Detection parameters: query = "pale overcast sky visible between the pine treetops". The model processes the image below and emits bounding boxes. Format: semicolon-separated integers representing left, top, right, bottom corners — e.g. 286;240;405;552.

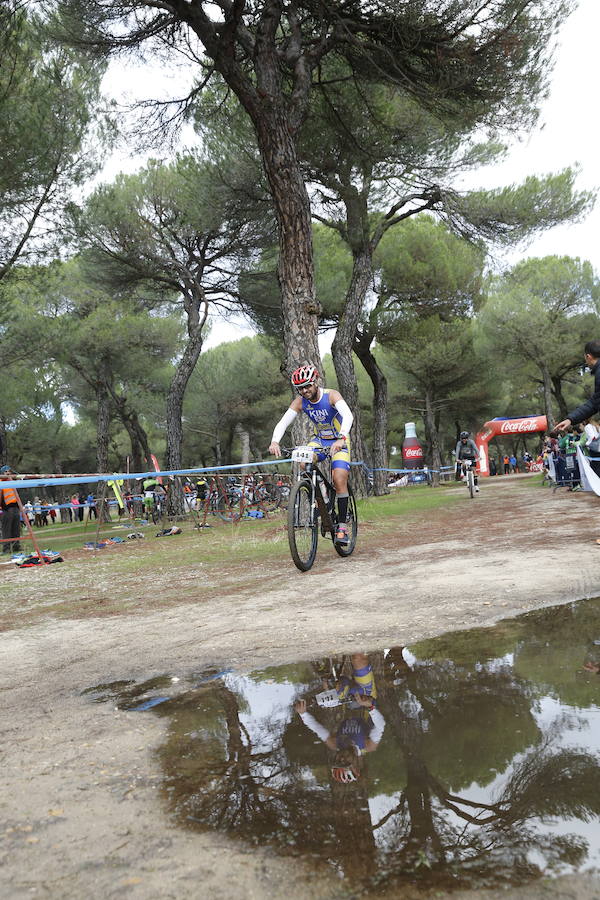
102;0;600;352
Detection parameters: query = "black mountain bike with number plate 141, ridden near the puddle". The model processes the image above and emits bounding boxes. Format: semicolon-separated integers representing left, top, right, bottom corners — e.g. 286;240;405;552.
287;447;358;572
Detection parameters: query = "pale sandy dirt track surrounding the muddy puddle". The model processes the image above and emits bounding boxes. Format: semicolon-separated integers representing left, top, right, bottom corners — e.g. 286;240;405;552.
0;476;600;900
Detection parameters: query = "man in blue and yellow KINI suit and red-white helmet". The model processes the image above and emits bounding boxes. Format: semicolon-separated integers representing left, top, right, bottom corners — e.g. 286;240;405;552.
269;365;354;544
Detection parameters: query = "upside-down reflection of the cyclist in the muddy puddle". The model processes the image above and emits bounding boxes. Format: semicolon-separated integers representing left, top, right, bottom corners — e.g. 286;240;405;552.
294;653;385;784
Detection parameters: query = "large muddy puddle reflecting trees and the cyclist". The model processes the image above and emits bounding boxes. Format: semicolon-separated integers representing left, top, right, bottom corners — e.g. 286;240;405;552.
85;600;600;889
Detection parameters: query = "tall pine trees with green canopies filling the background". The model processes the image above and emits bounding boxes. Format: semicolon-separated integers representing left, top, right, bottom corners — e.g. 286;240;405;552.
0;0;600;506
